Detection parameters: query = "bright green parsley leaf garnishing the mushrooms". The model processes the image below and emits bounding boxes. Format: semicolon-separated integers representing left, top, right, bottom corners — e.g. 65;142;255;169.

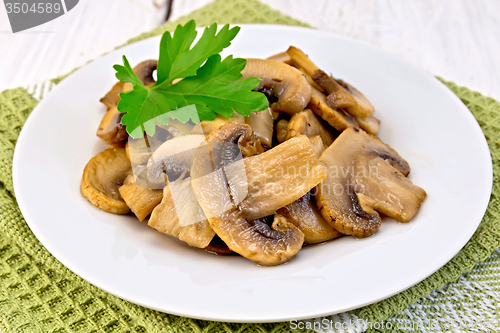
113;21;268;138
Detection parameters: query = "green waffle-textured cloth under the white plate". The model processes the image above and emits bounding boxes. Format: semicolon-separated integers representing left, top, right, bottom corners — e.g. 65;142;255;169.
0;0;500;333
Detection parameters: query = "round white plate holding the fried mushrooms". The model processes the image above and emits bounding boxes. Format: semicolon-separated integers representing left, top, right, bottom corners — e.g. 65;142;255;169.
13;25;492;322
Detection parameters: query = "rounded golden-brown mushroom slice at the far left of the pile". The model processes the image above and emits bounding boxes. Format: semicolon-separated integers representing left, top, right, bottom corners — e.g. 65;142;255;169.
80;148;131;214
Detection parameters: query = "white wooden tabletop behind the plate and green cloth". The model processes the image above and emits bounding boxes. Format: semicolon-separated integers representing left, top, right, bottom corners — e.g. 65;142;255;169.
0;0;500;100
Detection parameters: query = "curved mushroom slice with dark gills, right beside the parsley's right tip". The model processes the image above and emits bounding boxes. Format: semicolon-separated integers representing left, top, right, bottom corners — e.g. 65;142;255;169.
241;59;311;114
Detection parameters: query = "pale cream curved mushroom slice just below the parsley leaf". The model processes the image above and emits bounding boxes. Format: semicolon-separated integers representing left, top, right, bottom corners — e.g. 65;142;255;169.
146;134;205;188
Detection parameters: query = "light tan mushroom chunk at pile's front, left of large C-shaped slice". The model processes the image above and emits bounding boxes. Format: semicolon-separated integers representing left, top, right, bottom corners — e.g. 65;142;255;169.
148;178;215;249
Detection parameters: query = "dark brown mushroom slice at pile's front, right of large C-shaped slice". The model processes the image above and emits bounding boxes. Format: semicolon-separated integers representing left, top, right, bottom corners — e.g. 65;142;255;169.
278;193;342;244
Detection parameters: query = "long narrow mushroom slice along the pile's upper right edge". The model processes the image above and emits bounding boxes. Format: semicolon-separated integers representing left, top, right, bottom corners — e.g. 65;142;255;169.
287;46;375;118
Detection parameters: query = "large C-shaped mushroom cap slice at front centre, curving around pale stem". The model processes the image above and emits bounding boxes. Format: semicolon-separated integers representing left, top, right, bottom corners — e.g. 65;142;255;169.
191;123;307;265
